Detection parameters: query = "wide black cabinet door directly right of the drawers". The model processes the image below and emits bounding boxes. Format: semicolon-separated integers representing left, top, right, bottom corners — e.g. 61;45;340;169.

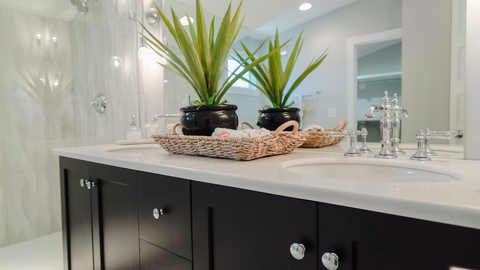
192;182;317;270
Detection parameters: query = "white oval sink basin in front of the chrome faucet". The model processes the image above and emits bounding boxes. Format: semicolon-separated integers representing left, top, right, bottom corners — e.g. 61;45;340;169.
282;159;466;183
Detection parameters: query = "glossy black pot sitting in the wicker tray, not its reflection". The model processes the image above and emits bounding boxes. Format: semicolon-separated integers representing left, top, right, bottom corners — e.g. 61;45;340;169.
180;104;238;136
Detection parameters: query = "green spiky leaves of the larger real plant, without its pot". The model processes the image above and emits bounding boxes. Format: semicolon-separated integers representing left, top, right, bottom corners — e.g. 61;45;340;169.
140;0;286;105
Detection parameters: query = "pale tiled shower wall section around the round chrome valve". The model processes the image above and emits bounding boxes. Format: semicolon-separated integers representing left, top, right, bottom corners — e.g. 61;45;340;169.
71;0;140;145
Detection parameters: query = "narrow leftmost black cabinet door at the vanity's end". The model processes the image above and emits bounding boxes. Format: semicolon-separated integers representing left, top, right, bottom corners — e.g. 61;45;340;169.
60;158;93;270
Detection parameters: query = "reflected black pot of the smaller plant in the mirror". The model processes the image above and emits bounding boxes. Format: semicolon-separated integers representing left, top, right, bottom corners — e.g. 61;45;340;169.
257;108;300;131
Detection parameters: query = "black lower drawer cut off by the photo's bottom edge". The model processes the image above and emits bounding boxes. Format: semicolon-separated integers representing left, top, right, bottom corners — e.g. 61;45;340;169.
140;240;192;270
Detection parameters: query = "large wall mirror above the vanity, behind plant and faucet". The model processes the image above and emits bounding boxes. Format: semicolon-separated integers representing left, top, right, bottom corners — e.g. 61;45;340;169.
165;0;466;152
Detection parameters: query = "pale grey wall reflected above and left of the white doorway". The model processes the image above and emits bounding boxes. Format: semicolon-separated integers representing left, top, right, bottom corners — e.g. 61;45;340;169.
281;0;402;128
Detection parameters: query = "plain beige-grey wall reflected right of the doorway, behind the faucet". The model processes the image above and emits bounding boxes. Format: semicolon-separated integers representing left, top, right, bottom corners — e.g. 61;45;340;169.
402;0;452;143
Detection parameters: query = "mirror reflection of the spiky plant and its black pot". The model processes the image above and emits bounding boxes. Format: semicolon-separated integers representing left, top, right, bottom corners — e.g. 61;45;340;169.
235;29;328;130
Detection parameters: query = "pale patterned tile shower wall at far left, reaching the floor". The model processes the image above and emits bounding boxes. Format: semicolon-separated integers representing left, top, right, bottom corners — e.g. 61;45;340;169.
0;5;77;246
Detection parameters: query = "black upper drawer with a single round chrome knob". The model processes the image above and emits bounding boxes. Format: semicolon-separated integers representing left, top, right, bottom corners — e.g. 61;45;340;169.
138;172;192;260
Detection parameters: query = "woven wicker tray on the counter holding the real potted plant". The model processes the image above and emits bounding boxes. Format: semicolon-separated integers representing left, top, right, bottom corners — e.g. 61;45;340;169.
152;121;309;160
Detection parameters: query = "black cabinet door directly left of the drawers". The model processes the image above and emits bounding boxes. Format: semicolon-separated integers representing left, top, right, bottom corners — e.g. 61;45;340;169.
91;164;140;270
